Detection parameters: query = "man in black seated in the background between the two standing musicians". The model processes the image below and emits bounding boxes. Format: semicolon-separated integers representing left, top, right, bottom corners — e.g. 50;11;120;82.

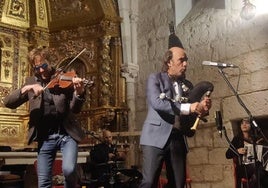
90;130;126;186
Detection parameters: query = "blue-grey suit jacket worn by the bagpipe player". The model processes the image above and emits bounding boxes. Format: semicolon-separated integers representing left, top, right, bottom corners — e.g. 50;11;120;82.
140;72;194;148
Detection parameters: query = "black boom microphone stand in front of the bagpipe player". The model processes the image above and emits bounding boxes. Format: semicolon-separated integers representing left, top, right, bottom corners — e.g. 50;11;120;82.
218;67;267;188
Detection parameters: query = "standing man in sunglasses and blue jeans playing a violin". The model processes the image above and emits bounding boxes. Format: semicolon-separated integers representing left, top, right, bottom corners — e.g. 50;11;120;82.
4;48;85;188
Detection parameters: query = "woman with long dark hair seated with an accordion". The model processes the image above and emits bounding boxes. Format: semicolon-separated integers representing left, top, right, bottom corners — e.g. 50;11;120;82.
225;118;267;188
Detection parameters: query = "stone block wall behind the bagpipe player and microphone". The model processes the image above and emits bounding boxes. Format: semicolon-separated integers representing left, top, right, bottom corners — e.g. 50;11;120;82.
136;0;268;188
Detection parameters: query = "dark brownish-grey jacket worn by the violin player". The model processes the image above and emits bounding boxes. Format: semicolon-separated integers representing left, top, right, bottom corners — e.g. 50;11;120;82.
4;76;85;144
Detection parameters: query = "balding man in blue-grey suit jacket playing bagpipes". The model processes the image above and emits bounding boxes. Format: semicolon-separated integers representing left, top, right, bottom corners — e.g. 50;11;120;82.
140;34;211;188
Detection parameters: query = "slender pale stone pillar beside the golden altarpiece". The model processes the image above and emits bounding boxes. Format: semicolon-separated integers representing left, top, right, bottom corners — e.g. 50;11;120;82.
118;0;139;167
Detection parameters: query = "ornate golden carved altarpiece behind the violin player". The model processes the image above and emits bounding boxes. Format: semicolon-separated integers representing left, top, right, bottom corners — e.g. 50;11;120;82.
0;0;128;148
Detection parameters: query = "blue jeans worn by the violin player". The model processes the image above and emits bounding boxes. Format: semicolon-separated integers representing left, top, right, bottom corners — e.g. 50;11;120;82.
37;134;78;188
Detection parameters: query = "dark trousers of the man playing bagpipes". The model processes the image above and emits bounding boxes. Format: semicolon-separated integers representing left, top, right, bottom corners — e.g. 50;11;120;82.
140;134;187;188
